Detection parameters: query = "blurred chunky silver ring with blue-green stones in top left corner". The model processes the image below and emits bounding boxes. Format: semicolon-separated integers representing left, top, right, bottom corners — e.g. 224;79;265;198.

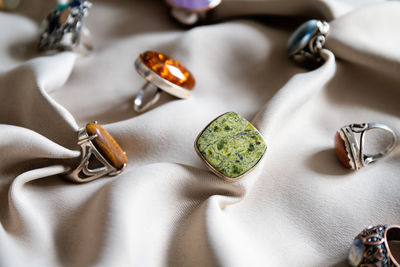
38;0;93;55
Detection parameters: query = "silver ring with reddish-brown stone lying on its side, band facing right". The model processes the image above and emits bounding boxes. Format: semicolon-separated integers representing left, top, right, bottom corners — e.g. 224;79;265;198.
335;122;397;170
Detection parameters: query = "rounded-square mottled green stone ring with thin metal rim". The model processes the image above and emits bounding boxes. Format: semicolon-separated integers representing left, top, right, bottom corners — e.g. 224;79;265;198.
196;112;267;178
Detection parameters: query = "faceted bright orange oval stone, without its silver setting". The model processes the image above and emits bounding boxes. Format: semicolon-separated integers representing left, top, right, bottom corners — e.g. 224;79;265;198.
140;51;195;90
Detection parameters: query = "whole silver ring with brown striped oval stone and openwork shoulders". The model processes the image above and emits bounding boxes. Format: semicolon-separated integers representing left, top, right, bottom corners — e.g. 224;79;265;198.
66;122;128;183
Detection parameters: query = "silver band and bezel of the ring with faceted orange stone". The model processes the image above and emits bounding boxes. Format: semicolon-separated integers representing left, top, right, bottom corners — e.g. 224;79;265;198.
133;57;192;112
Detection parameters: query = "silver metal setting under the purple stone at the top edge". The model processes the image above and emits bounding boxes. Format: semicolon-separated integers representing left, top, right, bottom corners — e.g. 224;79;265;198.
166;0;222;26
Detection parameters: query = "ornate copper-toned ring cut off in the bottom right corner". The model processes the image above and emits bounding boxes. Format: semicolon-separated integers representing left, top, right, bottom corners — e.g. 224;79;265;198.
348;225;400;267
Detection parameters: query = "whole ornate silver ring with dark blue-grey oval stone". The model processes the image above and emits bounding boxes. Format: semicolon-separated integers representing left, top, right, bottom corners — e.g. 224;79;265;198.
287;19;329;62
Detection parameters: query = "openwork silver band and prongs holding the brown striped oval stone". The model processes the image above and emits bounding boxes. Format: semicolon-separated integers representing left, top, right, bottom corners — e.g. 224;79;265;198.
66;122;126;183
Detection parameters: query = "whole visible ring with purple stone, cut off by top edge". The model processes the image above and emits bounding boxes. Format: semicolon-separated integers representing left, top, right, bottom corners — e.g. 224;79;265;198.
165;0;221;26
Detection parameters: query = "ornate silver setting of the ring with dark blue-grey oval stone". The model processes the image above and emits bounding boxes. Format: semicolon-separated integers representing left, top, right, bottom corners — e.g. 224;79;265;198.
288;20;330;62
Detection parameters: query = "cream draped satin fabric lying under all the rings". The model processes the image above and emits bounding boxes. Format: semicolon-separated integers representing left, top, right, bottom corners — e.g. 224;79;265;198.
0;0;400;267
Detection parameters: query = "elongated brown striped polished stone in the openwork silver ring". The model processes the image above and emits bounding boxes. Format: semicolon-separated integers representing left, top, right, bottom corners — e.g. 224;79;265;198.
86;122;128;170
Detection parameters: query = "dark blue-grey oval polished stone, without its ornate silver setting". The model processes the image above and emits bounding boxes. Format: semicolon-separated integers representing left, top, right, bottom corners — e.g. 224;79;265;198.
286;19;318;55
